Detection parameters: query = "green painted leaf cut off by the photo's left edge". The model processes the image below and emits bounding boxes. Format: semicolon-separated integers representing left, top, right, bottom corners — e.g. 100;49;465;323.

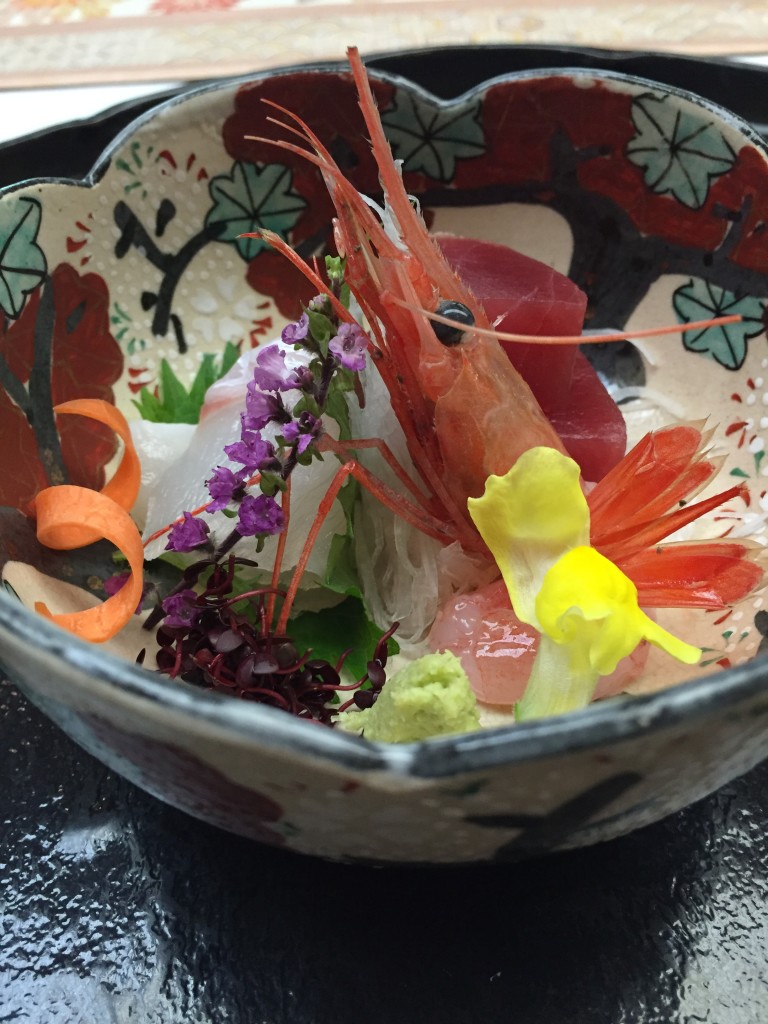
0;196;46;317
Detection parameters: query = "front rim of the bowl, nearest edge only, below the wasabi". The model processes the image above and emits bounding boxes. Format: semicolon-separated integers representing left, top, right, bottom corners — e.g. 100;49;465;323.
0;591;768;778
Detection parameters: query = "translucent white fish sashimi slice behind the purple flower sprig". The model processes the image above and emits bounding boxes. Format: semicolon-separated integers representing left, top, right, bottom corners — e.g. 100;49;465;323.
139;342;346;583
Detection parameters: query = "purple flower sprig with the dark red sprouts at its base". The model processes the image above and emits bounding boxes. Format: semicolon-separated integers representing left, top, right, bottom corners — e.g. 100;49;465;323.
144;259;405;725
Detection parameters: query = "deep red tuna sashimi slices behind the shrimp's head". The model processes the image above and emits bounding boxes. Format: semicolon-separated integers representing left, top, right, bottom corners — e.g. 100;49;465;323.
435;233;627;481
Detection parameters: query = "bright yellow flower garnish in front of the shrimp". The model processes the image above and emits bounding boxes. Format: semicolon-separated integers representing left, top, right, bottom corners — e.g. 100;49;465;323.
468;447;700;720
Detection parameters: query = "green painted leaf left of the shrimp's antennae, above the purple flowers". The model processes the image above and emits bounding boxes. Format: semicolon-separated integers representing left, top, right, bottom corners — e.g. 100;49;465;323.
206;161;306;260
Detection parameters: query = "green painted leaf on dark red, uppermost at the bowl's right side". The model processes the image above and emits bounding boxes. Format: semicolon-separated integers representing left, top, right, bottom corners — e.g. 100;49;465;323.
627;93;736;210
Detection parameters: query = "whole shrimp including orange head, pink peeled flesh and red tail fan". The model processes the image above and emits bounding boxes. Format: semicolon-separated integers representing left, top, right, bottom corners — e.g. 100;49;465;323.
257;49;762;703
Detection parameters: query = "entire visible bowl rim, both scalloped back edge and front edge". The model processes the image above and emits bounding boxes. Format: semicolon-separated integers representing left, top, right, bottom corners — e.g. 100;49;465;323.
0;60;768;778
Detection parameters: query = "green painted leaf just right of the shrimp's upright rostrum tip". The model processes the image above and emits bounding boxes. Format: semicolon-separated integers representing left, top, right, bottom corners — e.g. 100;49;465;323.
381;89;485;182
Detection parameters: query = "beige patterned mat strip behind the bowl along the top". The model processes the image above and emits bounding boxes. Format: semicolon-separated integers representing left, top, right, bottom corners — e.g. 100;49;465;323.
0;0;768;88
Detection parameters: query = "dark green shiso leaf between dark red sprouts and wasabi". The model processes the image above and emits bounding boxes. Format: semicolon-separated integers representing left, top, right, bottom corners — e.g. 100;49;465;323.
288;597;399;679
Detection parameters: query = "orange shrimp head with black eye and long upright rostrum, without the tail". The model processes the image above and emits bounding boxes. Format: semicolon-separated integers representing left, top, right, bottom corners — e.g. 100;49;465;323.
263;49;564;549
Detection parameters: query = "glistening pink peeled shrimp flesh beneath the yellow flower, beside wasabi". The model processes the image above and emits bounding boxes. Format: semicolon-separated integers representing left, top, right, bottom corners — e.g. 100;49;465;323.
427;580;648;706
